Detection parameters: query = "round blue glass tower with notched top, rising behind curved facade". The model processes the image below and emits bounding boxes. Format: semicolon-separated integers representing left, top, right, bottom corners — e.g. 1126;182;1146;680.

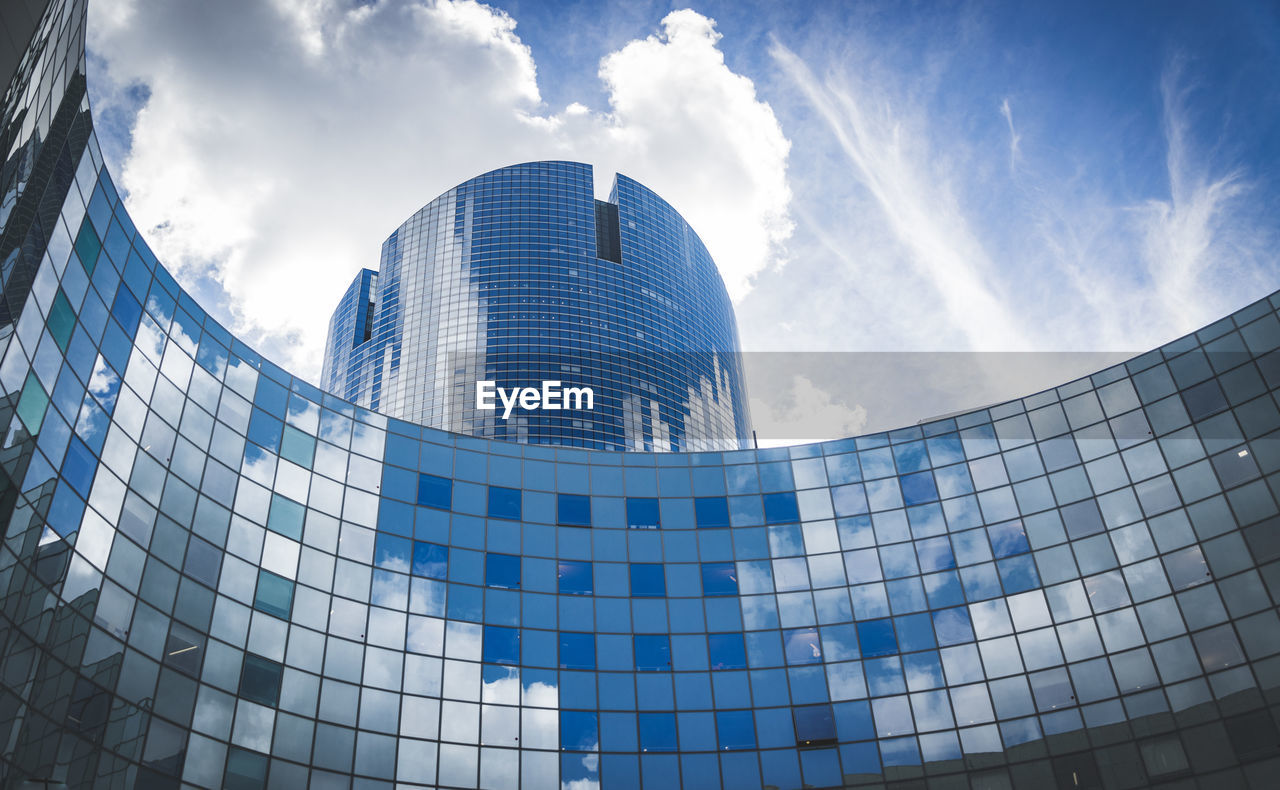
320;161;750;451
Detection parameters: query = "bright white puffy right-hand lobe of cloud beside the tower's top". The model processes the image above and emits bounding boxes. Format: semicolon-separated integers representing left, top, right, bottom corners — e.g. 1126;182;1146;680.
586;9;792;297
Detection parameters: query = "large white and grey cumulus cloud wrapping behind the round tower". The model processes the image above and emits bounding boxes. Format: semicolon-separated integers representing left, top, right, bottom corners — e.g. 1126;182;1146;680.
90;0;791;378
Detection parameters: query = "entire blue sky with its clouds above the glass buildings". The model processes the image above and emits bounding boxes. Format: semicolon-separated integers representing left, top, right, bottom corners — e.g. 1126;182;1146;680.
90;0;1280;428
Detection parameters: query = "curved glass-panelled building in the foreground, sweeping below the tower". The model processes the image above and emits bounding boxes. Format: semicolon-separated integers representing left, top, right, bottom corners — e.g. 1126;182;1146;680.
0;0;1280;790
